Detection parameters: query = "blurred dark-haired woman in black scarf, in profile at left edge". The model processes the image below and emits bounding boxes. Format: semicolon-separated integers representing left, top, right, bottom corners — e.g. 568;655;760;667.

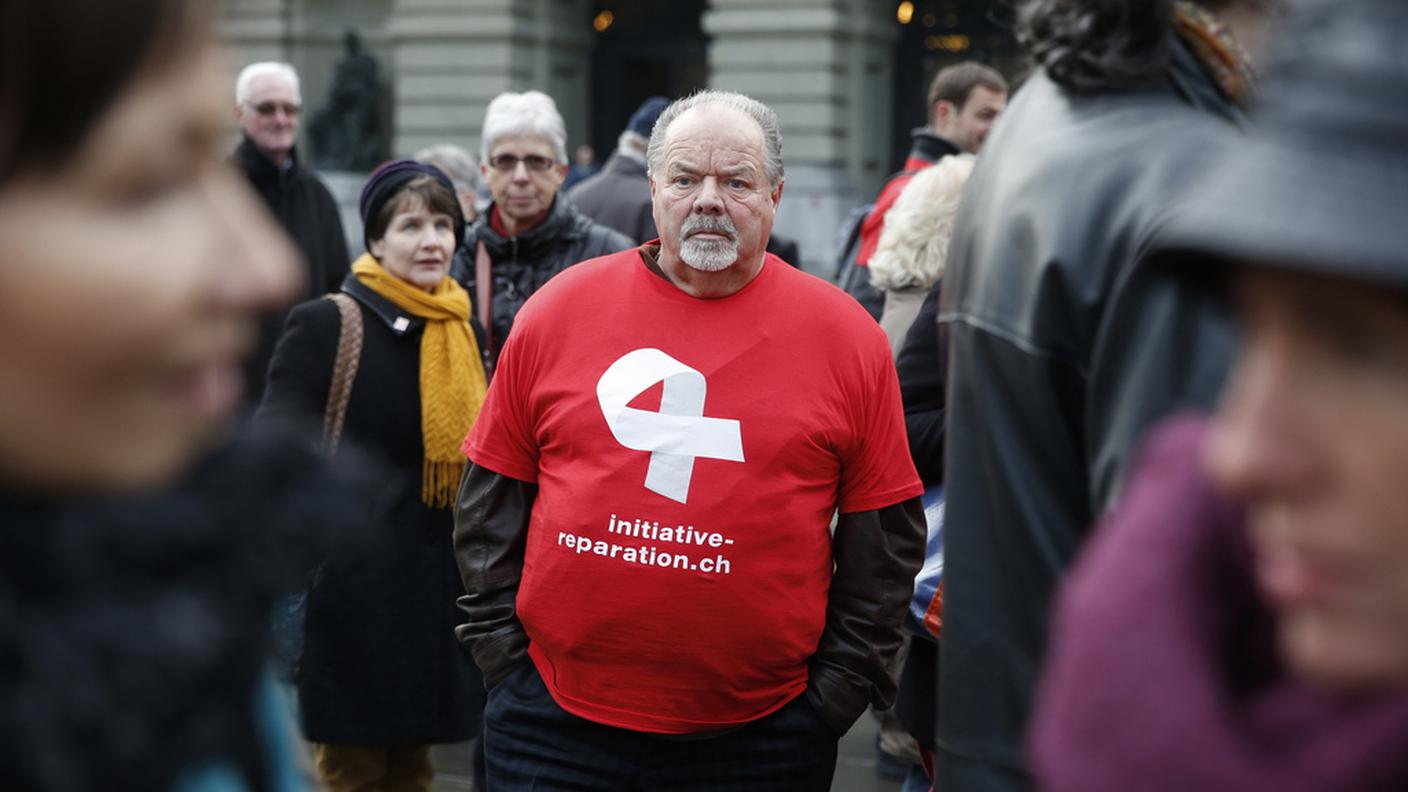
0;0;349;791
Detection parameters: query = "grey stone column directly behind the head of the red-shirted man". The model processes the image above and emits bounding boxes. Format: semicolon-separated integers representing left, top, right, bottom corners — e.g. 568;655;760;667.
704;0;897;276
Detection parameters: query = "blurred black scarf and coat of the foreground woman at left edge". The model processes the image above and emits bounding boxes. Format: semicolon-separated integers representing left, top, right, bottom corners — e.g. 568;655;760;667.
0;431;369;792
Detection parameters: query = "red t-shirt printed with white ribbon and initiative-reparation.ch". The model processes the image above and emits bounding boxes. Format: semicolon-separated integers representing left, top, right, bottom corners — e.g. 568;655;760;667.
465;249;922;733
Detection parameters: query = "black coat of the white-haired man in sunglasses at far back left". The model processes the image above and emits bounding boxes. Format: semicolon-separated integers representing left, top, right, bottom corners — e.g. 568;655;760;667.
234;138;351;404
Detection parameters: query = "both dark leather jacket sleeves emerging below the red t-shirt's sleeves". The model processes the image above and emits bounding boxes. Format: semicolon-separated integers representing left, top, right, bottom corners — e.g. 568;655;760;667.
455;464;925;736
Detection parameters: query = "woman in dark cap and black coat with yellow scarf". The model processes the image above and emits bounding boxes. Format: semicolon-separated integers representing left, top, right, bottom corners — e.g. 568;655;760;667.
259;161;486;792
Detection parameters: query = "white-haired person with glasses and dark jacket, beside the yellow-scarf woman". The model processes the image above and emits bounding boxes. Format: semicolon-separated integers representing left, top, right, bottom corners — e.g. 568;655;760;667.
452;90;634;366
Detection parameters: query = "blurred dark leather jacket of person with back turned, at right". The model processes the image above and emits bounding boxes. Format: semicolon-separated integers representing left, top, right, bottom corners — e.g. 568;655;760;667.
938;45;1242;792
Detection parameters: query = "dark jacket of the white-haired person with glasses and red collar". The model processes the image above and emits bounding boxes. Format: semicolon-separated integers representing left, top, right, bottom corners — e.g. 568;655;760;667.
451;196;634;364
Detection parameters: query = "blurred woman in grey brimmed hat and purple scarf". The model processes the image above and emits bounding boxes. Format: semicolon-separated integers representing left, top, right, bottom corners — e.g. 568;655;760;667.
1032;0;1408;792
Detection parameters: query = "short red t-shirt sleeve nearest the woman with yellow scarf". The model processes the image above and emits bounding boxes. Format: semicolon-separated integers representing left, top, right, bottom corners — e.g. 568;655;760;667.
462;323;539;483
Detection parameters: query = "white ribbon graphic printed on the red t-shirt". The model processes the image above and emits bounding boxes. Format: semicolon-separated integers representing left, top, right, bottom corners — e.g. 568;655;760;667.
597;349;743;503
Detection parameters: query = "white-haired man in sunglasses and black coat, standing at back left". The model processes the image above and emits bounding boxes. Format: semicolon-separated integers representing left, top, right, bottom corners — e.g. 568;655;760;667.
234;62;348;404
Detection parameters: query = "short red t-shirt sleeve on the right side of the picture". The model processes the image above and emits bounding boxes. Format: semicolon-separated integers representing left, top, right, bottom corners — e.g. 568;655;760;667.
841;326;924;514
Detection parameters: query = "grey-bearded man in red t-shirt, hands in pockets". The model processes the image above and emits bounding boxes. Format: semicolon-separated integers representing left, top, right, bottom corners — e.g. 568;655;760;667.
455;92;924;791
